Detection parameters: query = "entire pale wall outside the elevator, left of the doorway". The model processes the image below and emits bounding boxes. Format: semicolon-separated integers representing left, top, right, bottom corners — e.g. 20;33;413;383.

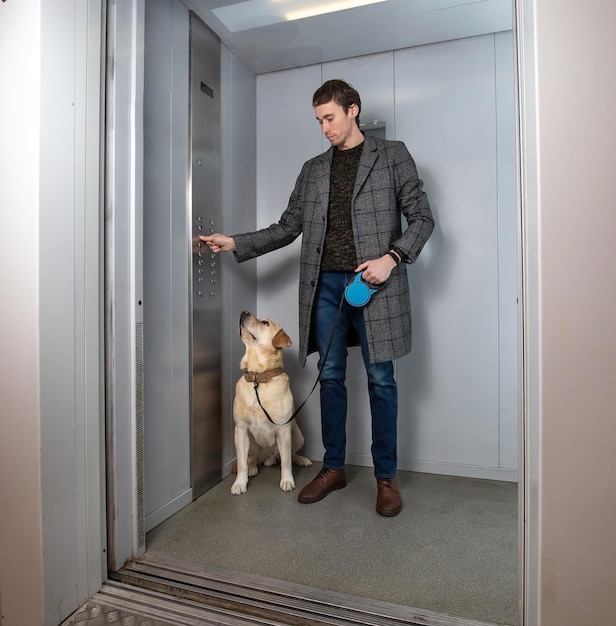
0;0;106;626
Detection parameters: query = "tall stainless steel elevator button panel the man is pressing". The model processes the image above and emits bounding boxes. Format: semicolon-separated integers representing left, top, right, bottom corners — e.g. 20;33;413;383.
190;14;222;498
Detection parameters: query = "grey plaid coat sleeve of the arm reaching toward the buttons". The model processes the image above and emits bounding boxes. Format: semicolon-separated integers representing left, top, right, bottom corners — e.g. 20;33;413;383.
233;163;309;263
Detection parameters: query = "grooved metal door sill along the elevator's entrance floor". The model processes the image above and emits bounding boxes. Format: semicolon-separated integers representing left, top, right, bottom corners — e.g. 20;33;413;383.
101;554;502;626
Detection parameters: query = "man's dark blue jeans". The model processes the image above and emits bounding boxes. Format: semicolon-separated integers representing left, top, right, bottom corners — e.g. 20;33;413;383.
312;272;398;478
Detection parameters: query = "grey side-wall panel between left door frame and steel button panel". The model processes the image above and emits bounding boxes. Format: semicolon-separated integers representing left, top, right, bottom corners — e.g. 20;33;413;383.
143;0;192;531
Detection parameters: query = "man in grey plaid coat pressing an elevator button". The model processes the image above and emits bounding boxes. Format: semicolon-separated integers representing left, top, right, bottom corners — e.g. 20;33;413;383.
201;80;434;517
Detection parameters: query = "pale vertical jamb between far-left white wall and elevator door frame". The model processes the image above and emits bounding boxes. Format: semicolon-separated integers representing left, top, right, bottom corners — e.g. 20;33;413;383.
38;0;106;623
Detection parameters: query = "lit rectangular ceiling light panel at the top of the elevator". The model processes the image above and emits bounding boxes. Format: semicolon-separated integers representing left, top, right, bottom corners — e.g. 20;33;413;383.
212;0;385;32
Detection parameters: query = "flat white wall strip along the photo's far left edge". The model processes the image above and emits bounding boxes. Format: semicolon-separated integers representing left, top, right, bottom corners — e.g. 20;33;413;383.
0;0;43;626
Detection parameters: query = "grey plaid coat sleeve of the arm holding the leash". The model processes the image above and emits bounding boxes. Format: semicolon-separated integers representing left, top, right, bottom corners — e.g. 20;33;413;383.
391;142;434;263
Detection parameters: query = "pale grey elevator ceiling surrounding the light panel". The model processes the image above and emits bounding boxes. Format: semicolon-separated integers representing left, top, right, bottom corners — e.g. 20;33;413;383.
182;0;513;74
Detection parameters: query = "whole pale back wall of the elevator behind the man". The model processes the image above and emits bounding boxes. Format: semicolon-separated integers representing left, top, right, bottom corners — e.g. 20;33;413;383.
257;33;519;480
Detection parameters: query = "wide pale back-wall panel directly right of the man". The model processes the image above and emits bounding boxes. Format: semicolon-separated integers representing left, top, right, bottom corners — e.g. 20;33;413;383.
395;35;510;472
